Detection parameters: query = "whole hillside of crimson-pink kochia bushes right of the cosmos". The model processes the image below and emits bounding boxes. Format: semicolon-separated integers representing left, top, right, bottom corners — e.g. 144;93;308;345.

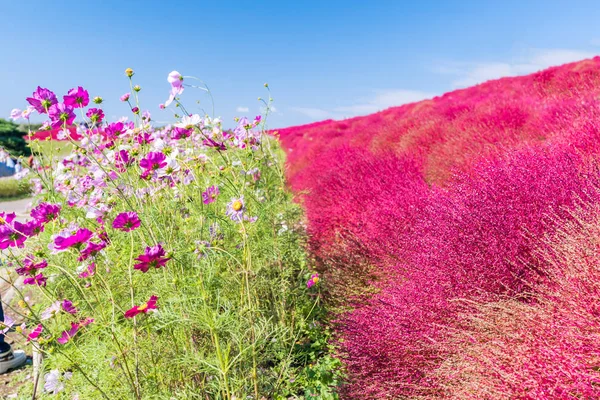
277;57;600;399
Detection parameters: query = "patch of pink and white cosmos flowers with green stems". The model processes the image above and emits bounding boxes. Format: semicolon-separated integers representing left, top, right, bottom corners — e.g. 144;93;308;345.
0;69;339;400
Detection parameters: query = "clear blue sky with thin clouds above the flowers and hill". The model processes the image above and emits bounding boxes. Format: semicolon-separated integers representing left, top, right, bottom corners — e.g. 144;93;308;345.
0;0;600;128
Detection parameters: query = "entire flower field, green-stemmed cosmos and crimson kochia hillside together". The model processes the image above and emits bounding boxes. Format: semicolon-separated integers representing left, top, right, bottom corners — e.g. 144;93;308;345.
0;57;600;400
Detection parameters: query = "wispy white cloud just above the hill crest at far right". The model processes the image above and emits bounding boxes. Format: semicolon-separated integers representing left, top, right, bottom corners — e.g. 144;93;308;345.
434;49;596;88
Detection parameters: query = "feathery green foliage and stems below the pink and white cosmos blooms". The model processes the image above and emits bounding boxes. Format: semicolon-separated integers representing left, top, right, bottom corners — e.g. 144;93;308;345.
14;136;340;399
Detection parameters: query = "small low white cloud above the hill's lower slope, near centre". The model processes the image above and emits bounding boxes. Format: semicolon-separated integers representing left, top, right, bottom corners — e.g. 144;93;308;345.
291;89;435;120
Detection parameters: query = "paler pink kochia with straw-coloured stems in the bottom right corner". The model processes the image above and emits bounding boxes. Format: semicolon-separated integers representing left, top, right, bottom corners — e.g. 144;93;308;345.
435;204;600;400
